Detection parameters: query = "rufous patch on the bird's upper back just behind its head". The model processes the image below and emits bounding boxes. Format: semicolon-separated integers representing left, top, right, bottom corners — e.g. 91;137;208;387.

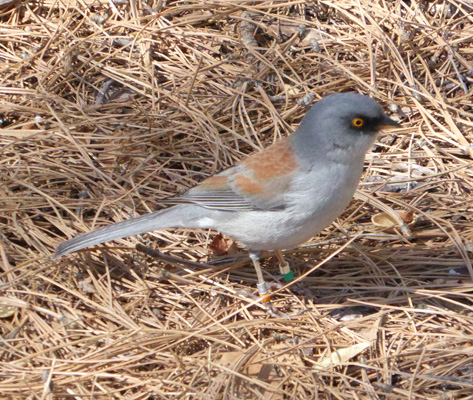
243;138;297;179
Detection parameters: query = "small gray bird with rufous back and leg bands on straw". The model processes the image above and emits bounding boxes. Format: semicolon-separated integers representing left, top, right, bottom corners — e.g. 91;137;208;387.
54;93;401;302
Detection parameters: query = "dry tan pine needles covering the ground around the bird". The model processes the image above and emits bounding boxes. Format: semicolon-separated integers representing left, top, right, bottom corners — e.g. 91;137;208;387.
0;0;473;400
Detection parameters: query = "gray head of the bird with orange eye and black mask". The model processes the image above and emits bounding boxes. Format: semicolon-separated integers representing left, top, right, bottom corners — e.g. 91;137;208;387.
294;93;401;162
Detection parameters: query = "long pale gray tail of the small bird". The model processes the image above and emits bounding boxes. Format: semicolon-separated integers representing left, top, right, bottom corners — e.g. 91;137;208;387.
54;206;200;259
